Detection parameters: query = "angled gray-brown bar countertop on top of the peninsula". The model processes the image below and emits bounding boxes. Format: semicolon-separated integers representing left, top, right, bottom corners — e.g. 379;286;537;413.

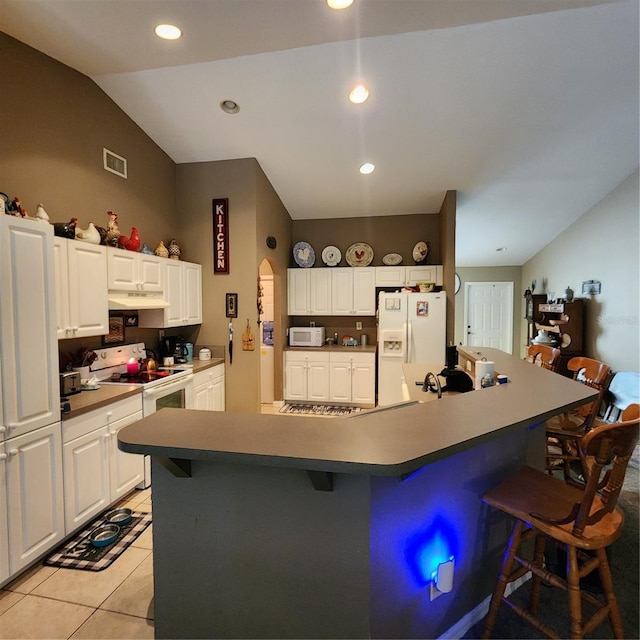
118;348;596;475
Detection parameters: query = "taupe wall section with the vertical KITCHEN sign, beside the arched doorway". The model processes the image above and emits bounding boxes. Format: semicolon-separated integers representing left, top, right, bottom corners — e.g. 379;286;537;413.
177;158;290;411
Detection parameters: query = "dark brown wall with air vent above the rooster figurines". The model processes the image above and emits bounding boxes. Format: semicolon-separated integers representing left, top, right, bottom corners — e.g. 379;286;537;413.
0;33;175;248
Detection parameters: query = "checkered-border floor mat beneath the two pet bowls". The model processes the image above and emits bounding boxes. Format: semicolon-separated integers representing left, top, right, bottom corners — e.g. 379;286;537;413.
44;509;151;571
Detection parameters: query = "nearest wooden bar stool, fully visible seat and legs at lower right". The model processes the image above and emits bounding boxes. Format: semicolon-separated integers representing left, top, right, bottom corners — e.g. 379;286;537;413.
482;405;640;638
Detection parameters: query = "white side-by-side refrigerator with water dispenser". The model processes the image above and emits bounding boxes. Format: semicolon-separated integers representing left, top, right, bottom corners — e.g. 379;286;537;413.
378;291;447;406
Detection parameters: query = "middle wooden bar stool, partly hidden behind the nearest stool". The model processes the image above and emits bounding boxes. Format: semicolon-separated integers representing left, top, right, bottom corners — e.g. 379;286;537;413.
546;356;609;482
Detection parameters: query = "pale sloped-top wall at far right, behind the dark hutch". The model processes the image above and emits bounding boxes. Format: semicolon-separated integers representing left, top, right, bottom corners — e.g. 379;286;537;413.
522;171;640;371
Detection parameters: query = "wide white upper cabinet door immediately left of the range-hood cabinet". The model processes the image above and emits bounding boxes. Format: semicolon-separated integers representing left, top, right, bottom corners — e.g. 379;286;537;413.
67;240;109;338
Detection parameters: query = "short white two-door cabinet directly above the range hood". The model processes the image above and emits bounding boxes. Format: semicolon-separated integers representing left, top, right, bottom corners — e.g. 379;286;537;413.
107;247;166;292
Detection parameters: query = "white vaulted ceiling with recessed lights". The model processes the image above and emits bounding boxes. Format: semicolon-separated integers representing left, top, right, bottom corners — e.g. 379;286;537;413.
0;0;639;266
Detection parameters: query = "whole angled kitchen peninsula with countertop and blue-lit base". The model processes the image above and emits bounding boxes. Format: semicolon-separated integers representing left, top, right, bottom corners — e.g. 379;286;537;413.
119;348;594;638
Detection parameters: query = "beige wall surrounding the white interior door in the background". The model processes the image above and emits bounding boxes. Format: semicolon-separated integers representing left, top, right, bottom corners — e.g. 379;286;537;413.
455;267;526;356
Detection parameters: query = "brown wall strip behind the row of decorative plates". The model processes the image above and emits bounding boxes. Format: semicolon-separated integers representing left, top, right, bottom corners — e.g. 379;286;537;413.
289;213;442;267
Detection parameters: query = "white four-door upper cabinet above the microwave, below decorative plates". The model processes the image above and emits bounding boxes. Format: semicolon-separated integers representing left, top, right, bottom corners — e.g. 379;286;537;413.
287;267;376;316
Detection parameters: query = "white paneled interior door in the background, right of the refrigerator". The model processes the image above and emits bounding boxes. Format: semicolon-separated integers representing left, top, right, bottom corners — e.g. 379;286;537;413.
464;282;513;353
